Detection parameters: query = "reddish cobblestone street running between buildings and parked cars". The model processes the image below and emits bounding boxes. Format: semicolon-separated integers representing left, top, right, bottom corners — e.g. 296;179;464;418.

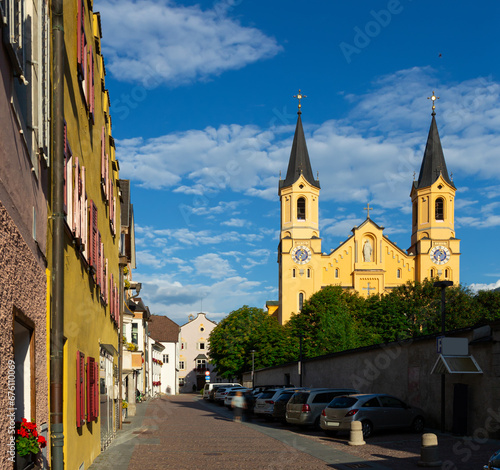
90;395;500;470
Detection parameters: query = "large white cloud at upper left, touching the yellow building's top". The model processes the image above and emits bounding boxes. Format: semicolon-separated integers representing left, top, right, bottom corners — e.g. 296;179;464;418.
94;0;282;88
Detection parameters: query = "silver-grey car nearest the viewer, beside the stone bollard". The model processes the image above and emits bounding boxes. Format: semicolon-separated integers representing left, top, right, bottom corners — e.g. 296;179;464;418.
320;393;425;439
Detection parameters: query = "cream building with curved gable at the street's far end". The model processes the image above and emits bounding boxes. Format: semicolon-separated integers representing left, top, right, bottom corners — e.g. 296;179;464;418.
178;313;217;393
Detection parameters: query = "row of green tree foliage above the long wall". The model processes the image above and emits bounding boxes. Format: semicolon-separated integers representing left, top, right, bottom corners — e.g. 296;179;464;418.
209;279;500;378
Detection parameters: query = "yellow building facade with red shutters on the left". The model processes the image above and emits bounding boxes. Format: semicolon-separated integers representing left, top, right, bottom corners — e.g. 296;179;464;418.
48;0;122;469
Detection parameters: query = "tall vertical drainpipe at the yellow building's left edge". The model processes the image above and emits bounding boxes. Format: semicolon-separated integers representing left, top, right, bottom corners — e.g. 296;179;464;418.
50;0;64;470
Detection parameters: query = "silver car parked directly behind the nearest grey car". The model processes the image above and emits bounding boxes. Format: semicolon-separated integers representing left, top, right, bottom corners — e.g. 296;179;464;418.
286;388;359;428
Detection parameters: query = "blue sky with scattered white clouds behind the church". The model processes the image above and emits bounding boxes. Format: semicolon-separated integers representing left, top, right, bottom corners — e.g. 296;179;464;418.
94;0;500;324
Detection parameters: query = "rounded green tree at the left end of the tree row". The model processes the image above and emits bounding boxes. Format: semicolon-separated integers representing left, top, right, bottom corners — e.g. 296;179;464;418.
209;305;293;378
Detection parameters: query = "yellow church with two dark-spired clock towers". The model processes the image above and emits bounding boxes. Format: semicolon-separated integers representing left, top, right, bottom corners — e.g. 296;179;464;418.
274;91;460;324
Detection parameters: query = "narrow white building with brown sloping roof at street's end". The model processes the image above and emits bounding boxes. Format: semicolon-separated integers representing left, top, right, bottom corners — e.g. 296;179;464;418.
148;315;179;395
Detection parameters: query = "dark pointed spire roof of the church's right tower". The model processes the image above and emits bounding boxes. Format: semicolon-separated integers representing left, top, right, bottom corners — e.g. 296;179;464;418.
413;112;455;189
